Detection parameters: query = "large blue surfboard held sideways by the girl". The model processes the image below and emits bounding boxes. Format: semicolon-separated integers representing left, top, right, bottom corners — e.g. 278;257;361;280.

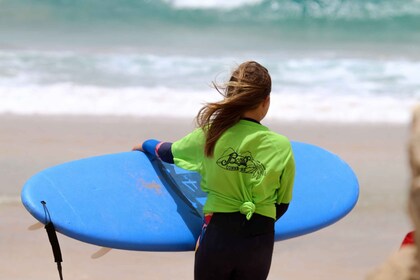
21;142;359;251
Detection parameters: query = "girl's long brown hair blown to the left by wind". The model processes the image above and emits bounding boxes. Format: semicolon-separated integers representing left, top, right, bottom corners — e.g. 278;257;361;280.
197;61;271;157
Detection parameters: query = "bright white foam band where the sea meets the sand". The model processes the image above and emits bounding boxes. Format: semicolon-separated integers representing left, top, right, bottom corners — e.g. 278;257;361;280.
0;84;416;123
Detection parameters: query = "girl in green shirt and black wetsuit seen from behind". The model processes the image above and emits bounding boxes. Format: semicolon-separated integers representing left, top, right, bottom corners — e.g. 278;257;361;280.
133;61;295;280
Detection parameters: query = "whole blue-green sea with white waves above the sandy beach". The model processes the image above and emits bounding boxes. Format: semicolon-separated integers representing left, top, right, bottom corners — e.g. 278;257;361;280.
0;0;420;123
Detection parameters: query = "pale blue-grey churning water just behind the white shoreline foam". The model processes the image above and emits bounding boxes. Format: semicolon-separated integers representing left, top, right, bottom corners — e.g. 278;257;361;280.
0;51;420;99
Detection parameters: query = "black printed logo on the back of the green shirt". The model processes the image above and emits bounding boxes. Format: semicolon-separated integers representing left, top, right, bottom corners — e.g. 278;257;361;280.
217;148;265;179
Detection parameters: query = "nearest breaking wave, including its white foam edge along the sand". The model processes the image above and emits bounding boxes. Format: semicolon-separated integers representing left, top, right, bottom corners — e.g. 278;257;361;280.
0;50;420;122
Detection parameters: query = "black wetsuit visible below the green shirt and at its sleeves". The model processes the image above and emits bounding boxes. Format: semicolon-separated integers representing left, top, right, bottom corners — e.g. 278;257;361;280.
156;139;289;280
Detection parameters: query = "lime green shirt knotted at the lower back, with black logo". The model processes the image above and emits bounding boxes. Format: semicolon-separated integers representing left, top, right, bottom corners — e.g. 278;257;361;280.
171;120;295;219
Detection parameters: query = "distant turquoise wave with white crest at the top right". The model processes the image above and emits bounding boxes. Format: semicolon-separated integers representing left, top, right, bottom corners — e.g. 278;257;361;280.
165;0;420;22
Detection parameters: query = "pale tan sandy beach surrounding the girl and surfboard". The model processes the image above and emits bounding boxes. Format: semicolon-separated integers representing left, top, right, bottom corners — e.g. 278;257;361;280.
0;115;411;280
